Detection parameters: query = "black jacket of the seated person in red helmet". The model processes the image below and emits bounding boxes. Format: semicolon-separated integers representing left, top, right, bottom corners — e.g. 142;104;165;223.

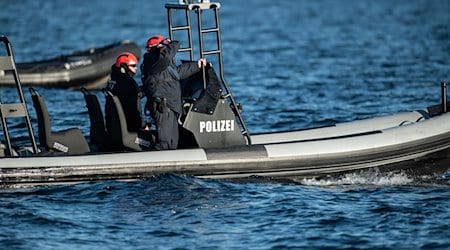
106;65;142;131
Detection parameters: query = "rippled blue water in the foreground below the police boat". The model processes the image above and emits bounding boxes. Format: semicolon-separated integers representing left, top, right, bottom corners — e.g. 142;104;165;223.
0;175;450;249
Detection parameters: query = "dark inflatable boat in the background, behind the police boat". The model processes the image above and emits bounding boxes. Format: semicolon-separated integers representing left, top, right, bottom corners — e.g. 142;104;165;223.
0;40;142;88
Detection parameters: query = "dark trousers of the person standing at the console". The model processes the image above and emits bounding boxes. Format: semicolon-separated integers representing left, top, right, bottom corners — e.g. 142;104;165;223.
154;108;179;150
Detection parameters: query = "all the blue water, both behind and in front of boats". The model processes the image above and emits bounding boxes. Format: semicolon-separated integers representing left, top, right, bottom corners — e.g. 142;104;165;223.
0;0;450;249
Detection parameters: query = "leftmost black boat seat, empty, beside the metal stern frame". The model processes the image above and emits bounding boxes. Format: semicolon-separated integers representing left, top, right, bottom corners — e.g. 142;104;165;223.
30;88;90;155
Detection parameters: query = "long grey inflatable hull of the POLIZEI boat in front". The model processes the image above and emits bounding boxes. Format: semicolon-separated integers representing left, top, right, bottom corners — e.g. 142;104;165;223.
0;110;450;186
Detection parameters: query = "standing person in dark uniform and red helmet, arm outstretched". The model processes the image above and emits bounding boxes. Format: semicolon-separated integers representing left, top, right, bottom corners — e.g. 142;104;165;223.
141;35;206;150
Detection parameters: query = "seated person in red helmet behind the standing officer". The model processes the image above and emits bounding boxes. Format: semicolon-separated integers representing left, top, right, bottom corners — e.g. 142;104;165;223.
105;52;143;132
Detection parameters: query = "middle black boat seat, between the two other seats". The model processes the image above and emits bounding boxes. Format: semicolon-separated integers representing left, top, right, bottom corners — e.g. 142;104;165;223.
81;88;109;152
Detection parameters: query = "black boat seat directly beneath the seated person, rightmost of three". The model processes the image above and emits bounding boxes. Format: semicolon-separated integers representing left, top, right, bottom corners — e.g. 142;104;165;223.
103;89;154;151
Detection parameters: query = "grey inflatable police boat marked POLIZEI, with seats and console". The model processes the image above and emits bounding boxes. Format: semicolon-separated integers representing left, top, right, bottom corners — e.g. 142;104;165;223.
0;1;450;187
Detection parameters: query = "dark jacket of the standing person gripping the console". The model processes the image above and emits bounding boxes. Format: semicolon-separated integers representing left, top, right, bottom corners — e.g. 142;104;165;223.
141;41;200;114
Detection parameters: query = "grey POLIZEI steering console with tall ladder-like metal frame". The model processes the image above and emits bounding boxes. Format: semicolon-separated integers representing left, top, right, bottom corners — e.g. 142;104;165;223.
165;0;251;148
